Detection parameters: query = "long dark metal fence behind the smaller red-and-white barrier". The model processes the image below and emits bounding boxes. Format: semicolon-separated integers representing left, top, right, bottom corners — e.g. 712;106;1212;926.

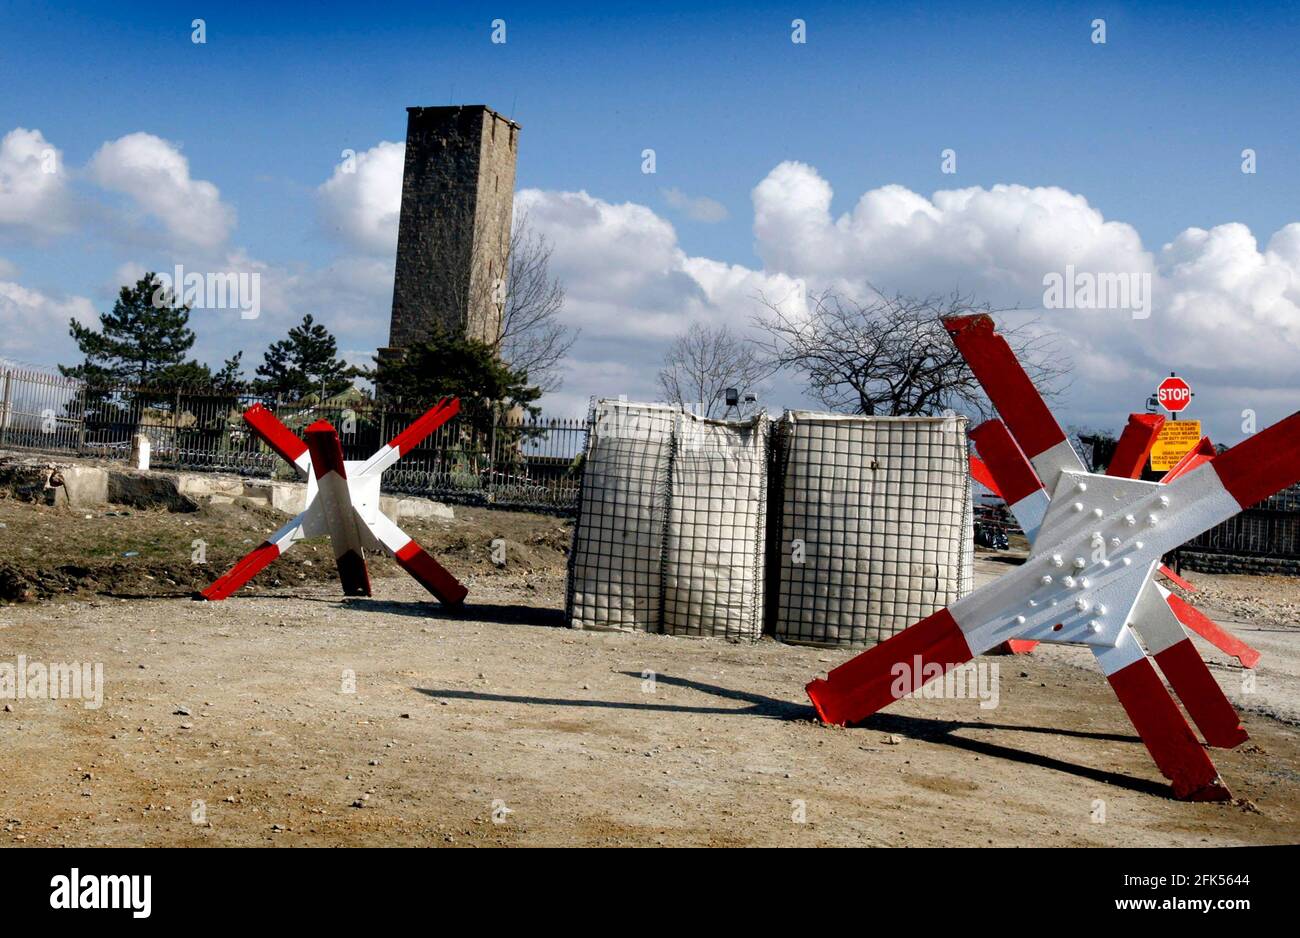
0;368;588;513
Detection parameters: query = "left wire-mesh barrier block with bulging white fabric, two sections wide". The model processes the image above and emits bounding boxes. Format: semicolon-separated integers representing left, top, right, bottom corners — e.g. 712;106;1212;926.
567;400;768;640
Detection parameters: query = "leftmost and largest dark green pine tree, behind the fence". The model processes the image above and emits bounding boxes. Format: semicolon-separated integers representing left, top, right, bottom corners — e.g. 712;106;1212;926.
59;273;212;388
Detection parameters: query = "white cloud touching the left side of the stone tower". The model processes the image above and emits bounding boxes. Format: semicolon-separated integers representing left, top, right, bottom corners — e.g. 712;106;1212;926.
316;140;406;257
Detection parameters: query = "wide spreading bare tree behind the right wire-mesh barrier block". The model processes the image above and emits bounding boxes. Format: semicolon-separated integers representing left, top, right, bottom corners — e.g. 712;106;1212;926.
757;287;1070;417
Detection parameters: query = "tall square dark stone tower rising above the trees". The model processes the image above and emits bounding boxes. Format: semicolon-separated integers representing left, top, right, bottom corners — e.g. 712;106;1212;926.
380;104;520;356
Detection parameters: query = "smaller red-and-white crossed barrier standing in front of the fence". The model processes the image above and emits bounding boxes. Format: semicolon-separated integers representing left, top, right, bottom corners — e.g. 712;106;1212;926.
200;398;468;605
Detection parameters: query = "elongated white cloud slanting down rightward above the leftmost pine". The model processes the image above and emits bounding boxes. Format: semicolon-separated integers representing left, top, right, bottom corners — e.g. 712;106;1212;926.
88;133;235;249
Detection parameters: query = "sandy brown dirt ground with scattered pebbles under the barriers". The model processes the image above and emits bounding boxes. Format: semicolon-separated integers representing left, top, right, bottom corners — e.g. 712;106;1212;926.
0;501;1300;846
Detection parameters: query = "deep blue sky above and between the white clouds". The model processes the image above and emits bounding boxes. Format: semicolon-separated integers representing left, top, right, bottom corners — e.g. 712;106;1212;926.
0;1;1300;433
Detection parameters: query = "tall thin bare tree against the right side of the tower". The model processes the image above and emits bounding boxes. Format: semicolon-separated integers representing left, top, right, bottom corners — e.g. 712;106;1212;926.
491;214;579;391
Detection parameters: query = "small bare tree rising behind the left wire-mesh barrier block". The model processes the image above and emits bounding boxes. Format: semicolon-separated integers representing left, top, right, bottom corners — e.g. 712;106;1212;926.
659;322;772;417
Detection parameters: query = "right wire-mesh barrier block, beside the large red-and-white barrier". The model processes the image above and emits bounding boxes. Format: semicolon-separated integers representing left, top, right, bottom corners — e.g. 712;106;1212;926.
768;411;974;646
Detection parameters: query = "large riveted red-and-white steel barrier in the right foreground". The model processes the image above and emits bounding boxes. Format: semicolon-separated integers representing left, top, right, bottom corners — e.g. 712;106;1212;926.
807;316;1300;800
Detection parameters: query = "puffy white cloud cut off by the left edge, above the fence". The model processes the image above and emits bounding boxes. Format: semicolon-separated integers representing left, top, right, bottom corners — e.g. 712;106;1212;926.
0;127;73;238
